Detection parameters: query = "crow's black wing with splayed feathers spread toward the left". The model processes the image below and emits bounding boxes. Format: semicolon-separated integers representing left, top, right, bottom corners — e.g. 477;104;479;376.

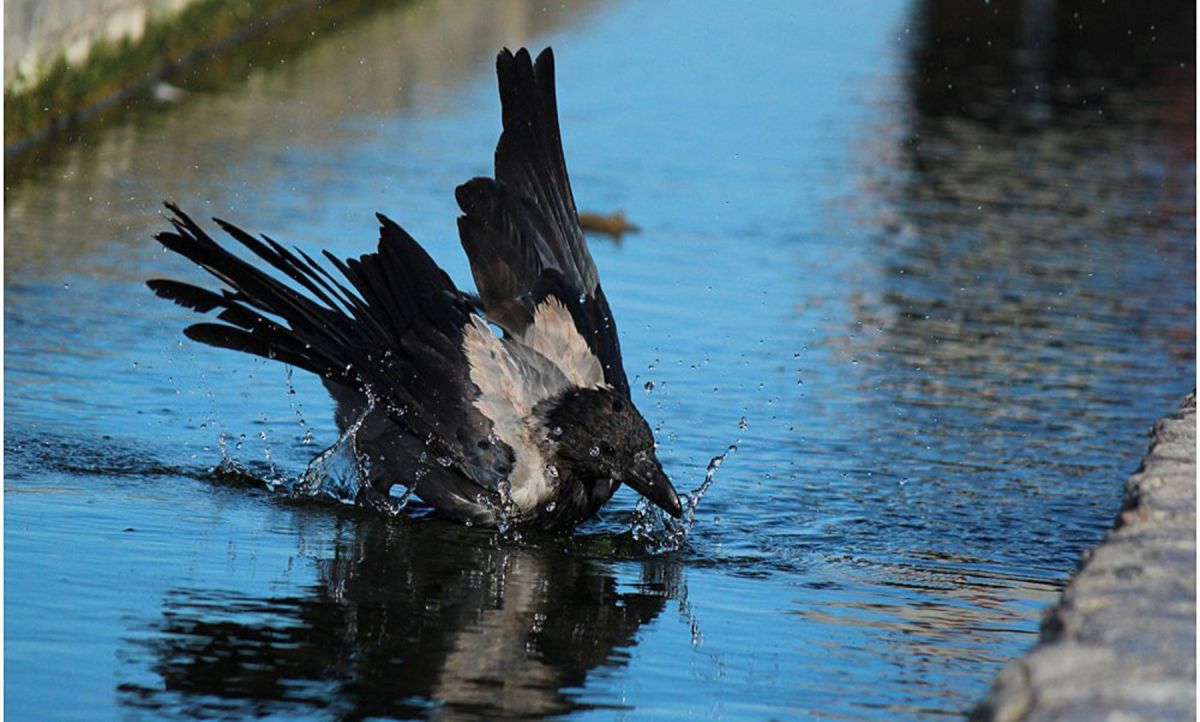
148;204;512;491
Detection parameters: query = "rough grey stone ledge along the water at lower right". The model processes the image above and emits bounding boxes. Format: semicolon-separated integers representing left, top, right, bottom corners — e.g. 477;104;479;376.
971;391;1196;722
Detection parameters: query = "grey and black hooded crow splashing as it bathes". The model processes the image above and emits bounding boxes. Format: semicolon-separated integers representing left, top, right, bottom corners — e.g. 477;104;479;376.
148;48;682;530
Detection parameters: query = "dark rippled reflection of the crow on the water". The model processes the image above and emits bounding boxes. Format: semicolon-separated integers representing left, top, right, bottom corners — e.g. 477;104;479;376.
118;518;682;720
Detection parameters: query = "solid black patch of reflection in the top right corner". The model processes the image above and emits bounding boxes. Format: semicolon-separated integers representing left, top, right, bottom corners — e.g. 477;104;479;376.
907;0;1195;131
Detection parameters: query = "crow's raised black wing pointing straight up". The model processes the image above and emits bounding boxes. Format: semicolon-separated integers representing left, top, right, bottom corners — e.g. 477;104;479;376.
455;48;629;396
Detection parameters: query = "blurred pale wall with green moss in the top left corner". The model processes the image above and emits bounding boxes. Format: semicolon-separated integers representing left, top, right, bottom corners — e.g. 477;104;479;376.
4;0;390;157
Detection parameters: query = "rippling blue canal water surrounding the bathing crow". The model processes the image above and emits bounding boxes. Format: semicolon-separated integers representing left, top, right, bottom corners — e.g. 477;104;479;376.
5;1;1195;720
